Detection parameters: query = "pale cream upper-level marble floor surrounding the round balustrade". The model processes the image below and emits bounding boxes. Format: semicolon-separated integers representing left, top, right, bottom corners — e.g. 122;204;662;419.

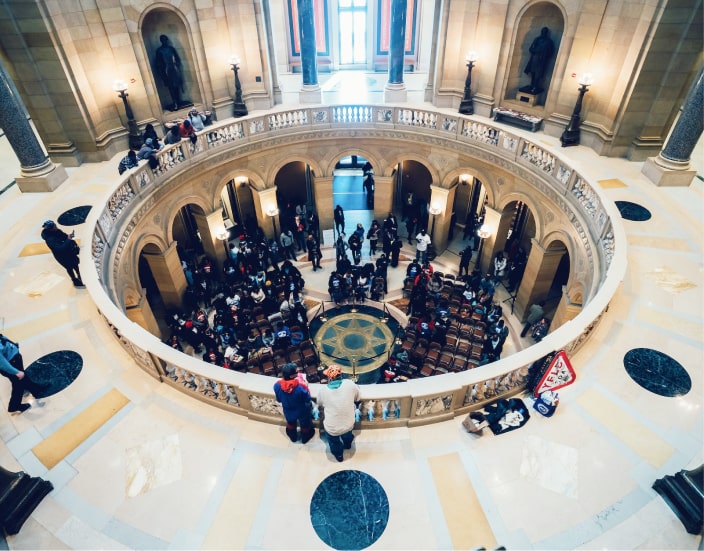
0;80;704;549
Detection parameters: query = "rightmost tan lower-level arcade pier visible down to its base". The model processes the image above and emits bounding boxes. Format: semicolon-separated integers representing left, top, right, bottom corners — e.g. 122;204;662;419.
516;239;567;319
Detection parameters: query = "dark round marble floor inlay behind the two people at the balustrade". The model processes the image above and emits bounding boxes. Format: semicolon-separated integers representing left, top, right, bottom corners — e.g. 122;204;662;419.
310;470;389;549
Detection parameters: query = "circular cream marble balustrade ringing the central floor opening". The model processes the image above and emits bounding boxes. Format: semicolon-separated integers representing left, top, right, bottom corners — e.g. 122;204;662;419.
81;105;626;432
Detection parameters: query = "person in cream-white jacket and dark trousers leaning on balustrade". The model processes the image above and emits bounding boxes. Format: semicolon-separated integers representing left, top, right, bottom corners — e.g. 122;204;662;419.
318;365;360;461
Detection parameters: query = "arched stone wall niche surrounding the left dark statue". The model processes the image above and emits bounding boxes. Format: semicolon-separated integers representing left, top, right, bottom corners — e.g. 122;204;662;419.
137;2;204;112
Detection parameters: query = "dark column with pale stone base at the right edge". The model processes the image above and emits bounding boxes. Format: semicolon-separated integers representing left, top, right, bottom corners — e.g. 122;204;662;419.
642;69;704;186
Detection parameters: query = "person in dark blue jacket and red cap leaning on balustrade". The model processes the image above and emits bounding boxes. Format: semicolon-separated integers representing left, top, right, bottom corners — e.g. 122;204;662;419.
274;363;315;444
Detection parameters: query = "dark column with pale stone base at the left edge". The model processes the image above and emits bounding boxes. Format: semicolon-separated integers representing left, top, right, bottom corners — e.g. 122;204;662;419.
0;58;68;192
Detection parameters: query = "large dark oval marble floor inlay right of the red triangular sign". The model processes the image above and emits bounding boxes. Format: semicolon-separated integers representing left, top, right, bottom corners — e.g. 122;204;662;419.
623;348;692;397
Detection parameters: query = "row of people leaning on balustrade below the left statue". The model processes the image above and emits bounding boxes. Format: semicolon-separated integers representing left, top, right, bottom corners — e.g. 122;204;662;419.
117;108;208;174
